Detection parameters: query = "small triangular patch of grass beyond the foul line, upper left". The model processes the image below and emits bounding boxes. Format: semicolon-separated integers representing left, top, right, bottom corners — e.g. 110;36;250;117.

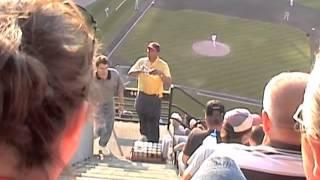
87;0;142;48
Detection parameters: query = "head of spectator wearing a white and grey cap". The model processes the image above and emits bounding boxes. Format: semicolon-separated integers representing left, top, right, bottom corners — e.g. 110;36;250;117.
221;108;260;145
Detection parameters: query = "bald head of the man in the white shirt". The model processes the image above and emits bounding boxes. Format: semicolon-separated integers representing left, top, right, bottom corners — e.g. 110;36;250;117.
263;72;309;131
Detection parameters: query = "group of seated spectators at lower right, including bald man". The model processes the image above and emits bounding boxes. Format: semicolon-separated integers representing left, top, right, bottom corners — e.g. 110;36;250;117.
170;68;320;180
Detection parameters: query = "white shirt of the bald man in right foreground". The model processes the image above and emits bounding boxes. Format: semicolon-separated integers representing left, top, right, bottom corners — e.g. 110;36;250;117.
185;143;305;177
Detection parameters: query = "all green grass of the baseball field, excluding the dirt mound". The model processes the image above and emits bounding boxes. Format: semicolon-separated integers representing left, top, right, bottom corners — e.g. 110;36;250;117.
82;0;320;115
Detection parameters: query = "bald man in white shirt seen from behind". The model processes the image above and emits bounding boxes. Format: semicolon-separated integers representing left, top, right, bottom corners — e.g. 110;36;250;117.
183;72;309;180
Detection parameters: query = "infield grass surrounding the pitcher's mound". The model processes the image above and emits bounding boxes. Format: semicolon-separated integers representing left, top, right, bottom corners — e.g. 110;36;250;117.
116;9;310;103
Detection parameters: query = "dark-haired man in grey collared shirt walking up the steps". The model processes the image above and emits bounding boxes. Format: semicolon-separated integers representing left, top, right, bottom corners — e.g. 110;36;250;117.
89;55;124;155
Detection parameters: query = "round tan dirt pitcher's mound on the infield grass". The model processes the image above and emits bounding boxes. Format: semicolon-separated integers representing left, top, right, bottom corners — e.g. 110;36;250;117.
192;40;230;57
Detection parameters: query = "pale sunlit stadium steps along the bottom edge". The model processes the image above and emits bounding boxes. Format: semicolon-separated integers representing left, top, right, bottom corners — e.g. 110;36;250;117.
59;156;177;180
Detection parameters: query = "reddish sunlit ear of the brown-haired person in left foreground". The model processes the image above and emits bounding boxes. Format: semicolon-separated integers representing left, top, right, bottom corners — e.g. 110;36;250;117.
60;102;89;164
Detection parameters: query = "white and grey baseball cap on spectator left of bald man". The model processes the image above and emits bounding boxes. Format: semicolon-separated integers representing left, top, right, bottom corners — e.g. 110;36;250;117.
224;108;261;133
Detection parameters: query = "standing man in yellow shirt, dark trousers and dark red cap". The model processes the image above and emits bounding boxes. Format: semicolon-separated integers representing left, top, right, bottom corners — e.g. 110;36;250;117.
128;42;172;142
